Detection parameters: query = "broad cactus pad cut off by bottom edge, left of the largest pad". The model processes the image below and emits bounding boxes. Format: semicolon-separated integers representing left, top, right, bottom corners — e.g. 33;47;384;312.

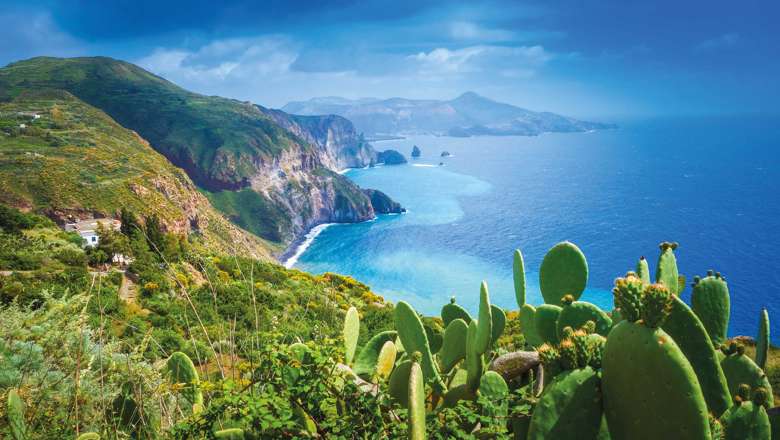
527;367;603;440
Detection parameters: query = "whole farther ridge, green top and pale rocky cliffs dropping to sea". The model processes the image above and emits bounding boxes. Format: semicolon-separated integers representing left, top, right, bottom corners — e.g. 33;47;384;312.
0;57;400;245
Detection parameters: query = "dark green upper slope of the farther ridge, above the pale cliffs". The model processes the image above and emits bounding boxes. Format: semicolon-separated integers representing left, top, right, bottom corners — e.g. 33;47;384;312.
0;57;308;189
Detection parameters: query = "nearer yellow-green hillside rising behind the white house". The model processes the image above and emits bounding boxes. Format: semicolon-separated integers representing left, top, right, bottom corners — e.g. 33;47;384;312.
0;87;275;258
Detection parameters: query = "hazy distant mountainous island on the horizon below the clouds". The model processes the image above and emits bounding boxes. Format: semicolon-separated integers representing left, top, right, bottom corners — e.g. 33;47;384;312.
282;92;616;138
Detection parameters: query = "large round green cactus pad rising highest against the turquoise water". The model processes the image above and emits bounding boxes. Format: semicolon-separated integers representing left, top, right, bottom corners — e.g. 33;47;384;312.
539;241;588;305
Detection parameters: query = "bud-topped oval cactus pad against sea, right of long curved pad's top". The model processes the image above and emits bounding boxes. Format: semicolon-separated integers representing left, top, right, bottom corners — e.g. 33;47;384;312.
691;271;731;346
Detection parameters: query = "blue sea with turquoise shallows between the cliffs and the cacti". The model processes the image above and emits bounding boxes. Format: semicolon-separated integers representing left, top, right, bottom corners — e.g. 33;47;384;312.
296;117;780;342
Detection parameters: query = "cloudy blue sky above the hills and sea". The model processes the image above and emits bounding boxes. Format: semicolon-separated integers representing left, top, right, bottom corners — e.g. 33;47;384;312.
0;0;780;118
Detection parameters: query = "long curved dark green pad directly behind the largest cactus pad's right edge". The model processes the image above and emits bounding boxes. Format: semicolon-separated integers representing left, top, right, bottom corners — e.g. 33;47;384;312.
663;296;731;417
